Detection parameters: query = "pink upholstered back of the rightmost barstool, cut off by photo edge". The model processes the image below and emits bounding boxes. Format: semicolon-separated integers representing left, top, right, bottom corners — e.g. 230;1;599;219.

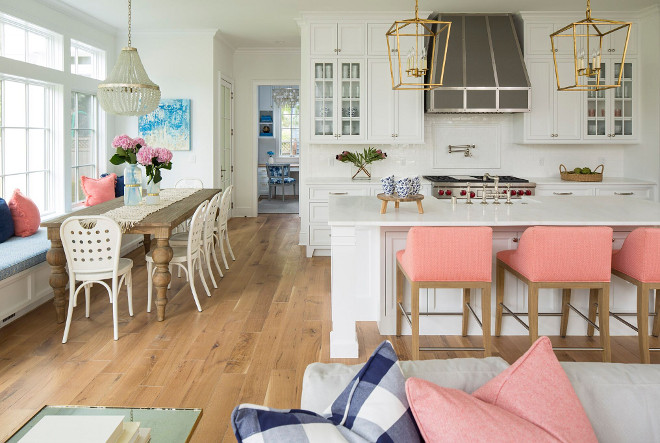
612;228;660;283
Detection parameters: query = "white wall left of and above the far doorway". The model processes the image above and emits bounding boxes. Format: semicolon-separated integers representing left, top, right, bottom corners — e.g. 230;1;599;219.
233;49;305;217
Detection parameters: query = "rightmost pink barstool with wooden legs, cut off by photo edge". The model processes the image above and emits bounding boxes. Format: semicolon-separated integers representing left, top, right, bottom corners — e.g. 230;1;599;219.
610;228;660;363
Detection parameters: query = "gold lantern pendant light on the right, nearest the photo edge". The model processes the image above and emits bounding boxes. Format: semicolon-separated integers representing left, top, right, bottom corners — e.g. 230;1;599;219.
550;0;632;91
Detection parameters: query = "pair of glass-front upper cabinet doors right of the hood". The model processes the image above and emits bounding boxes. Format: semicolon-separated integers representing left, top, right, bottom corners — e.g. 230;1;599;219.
584;59;638;142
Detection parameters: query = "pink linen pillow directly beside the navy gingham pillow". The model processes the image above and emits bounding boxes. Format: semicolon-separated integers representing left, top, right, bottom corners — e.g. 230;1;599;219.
406;377;557;443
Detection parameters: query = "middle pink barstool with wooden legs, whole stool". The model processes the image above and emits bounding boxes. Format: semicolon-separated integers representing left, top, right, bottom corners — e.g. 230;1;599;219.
495;226;612;362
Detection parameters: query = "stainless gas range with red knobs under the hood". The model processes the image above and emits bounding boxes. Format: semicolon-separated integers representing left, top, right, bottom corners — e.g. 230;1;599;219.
424;174;536;199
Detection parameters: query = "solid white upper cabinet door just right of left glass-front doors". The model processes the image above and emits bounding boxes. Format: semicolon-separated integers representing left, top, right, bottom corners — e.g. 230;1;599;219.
367;59;395;143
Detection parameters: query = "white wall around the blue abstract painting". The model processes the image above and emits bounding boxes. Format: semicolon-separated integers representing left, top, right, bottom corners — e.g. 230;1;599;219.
116;31;215;187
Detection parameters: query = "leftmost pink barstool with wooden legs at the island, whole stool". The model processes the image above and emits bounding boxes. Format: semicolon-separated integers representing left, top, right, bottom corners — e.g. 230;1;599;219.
396;227;493;360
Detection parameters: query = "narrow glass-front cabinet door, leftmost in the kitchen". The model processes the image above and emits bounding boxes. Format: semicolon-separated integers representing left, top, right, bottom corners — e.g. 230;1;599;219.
311;60;337;142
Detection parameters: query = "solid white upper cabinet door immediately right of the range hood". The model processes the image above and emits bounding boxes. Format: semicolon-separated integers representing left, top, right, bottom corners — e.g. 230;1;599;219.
524;59;556;141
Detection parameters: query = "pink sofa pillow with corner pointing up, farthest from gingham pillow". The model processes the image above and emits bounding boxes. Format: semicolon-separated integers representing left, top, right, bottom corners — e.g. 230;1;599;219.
472;337;598;443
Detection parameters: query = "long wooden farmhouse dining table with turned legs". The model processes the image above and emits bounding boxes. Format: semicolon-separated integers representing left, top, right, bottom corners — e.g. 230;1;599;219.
41;189;221;323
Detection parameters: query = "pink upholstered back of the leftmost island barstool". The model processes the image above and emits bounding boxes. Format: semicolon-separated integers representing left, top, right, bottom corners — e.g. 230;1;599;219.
397;226;493;282
